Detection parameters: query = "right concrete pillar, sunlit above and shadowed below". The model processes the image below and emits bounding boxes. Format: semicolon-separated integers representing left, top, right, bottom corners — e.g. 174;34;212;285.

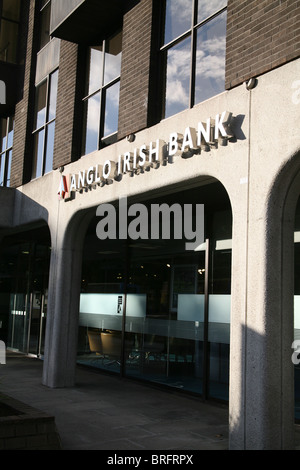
229;163;300;450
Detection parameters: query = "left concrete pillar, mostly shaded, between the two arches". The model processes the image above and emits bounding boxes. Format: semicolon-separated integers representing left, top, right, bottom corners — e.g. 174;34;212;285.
43;211;90;388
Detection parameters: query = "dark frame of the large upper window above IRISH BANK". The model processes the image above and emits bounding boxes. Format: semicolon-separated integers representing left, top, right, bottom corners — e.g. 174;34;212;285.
159;0;228;119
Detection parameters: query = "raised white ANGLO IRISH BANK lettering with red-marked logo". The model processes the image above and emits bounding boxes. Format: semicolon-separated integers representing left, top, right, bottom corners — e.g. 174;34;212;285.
58;111;233;201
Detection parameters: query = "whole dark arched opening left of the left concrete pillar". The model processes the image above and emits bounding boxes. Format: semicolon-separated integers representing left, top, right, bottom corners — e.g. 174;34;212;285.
0;224;51;356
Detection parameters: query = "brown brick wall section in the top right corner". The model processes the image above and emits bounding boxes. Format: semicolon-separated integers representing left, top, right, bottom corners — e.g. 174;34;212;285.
226;0;300;89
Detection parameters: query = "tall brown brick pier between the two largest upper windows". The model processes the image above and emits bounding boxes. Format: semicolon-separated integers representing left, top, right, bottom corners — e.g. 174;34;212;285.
118;0;152;139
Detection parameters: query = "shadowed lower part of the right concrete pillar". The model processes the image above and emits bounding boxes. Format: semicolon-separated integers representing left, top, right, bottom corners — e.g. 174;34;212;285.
229;325;300;450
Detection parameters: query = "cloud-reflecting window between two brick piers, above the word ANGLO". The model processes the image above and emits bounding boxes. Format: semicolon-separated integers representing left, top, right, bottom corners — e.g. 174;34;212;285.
82;32;122;155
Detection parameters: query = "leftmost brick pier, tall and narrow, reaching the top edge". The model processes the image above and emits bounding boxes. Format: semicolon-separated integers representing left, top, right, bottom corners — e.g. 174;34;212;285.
10;0;37;187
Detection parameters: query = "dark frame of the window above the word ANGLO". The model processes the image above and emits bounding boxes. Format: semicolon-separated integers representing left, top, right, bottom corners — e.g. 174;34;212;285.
81;29;123;156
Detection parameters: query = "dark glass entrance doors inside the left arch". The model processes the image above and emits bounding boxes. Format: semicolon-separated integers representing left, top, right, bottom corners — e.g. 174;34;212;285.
4;237;50;356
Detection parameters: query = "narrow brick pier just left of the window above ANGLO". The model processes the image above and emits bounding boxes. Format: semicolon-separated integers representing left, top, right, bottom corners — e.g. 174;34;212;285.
53;41;85;169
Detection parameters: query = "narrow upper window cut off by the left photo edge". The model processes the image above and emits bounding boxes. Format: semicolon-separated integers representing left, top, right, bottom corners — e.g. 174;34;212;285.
0;117;14;187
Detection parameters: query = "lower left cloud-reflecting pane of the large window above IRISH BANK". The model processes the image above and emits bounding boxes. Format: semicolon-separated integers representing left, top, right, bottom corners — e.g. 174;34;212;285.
164;38;191;117
